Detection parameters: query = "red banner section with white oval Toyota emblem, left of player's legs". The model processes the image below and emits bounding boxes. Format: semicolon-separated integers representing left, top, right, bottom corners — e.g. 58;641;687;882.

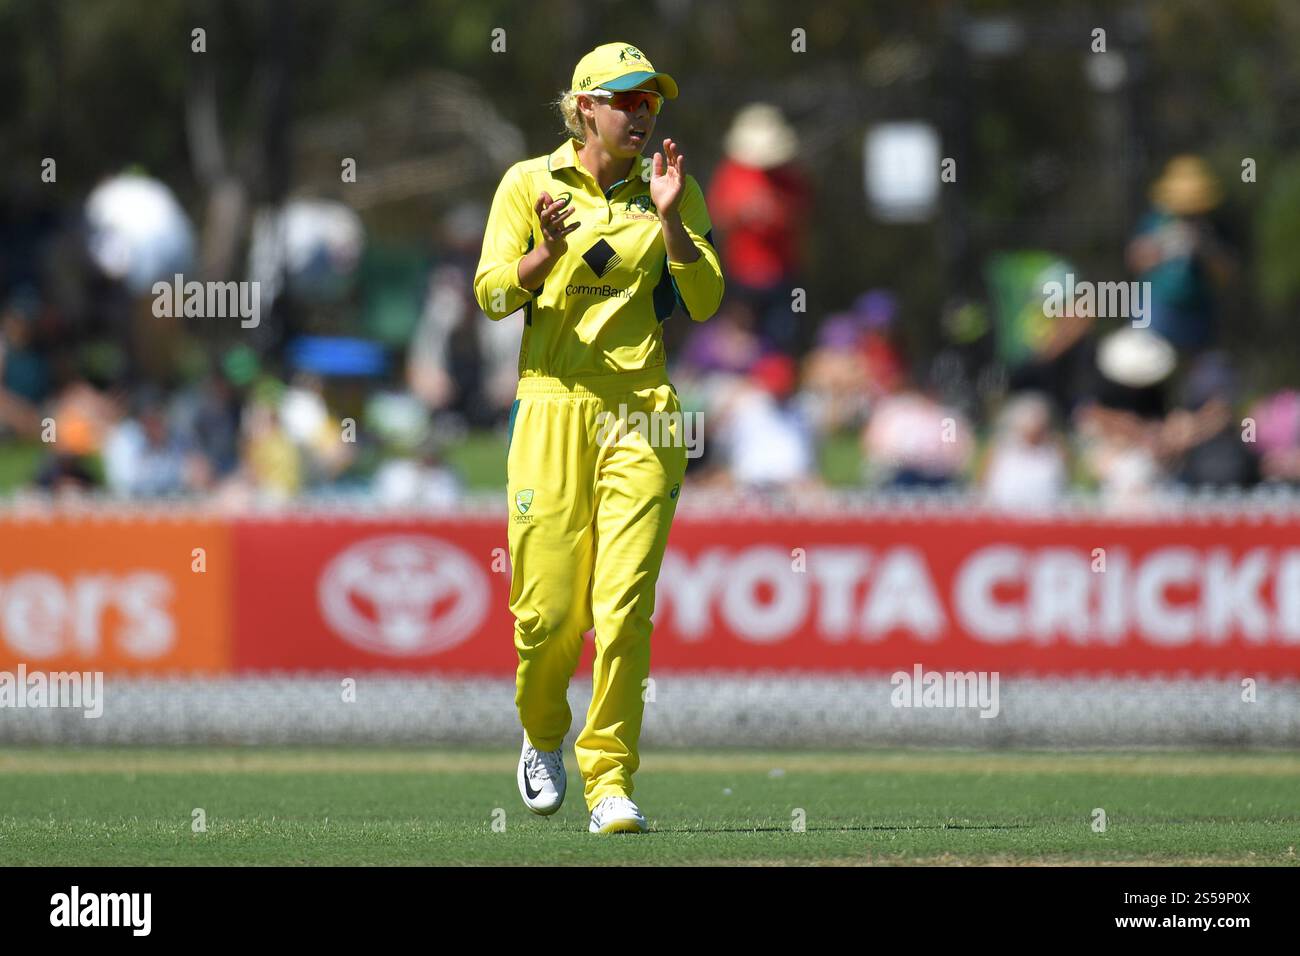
234;518;515;675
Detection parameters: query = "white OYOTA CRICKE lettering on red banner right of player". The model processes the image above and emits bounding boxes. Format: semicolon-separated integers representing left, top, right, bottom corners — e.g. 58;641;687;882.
658;541;1300;648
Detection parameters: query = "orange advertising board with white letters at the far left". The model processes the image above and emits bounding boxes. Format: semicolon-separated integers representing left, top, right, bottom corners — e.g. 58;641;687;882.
0;515;231;675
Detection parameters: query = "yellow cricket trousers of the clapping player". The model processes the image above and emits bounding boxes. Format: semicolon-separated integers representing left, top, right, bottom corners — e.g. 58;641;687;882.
507;368;686;809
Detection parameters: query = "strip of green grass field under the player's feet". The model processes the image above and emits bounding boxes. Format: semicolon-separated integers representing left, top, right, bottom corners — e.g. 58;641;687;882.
0;748;1300;866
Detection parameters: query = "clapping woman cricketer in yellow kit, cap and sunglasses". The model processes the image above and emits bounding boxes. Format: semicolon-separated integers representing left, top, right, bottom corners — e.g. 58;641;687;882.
475;43;723;832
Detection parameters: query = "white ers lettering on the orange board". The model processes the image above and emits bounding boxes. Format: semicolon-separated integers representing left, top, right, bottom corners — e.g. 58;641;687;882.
0;571;176;661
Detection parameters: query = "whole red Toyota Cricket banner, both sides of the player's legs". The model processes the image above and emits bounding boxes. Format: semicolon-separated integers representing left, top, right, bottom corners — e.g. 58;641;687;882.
233;516;1300;676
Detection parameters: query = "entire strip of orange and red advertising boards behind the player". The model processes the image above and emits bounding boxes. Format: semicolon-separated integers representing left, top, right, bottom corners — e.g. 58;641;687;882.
0;514;1300;678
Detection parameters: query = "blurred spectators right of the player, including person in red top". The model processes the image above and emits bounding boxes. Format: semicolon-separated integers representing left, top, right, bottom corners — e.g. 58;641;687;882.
675;136;1300;510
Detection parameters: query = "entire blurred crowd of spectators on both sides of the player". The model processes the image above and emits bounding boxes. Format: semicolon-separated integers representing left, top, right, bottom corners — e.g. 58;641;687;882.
0;104;1300;510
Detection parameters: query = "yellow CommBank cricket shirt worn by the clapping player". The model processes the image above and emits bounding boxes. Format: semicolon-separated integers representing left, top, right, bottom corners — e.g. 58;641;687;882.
475;139;723;378
